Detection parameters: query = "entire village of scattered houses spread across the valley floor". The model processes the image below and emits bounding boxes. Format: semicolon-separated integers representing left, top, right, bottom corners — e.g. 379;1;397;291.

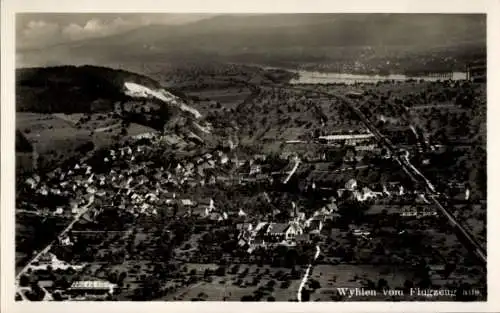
14;121;480;300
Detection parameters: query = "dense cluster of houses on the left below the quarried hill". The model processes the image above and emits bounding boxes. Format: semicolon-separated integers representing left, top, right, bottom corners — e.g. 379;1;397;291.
21;133;259;215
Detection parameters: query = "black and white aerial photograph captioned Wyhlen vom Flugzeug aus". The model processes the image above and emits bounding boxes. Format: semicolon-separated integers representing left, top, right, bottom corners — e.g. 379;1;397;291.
2;0;495;305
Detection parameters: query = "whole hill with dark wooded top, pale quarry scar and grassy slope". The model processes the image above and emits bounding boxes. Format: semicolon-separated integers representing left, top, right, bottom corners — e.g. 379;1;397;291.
16;66;211;171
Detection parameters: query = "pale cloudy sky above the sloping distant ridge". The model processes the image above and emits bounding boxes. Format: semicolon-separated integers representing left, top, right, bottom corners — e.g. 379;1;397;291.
16;13;213;49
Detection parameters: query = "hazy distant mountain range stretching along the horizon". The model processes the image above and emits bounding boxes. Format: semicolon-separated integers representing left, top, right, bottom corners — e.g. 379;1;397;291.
17;14;486;66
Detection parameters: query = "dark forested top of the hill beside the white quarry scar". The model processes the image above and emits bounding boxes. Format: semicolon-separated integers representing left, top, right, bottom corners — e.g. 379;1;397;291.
16;66;159;113
